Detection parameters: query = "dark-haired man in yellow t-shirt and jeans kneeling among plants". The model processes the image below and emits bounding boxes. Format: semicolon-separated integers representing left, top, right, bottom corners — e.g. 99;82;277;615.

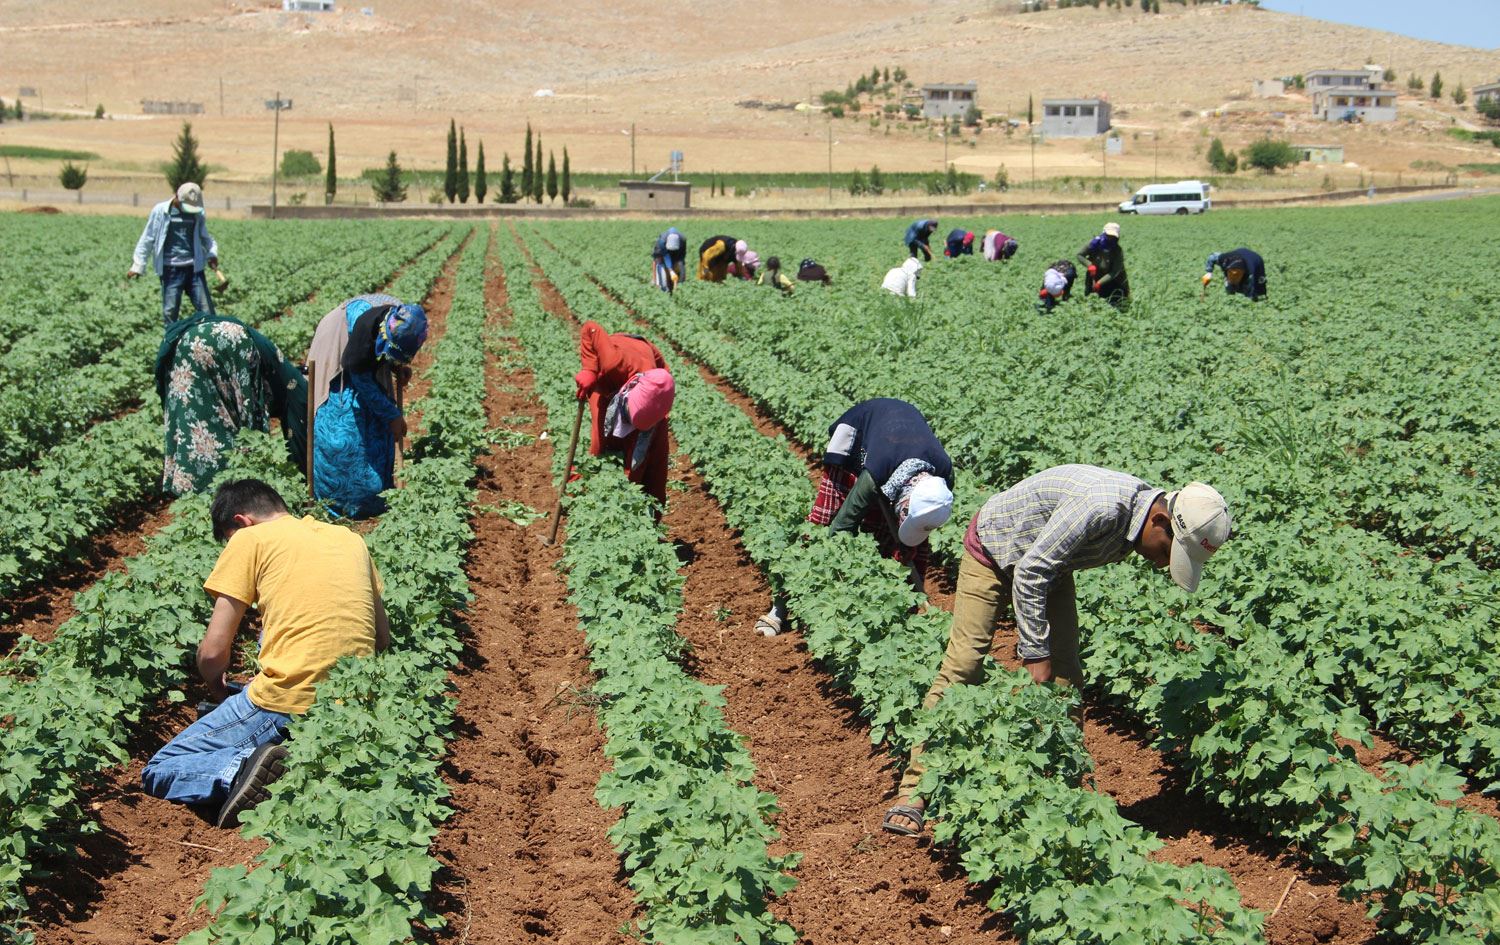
141;479;390;827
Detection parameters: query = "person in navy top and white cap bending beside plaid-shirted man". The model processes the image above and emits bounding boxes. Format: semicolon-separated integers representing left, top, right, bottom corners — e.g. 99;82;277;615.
755;398;953;636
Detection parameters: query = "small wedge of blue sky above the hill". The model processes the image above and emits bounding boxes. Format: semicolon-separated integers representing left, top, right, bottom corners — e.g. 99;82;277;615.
1260;0;1500;50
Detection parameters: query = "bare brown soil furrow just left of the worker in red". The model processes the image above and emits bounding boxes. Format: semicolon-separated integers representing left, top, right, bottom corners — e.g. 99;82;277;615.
437;231;636;945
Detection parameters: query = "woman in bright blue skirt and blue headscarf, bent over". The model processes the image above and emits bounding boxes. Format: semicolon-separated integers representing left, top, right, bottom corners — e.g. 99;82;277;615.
308;294;428;519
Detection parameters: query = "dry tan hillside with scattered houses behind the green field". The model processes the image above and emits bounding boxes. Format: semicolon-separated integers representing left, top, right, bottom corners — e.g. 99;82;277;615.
0;0;1500;188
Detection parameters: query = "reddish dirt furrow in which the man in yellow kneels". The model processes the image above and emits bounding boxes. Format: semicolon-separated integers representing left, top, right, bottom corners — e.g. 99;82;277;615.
27;237;468;945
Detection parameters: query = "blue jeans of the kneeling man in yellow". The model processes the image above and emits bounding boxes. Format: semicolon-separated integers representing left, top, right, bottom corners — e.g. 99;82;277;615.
141;690;291;804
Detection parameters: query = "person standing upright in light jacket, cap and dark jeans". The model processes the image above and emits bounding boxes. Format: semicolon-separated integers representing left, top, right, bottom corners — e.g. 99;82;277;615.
125;180;219;327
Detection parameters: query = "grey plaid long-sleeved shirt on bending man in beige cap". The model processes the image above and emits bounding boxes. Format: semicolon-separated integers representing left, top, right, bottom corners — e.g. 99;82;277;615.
971;465;1164;660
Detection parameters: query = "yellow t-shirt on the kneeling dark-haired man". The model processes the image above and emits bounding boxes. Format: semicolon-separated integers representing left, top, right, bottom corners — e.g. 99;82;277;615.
203;515;381;714
